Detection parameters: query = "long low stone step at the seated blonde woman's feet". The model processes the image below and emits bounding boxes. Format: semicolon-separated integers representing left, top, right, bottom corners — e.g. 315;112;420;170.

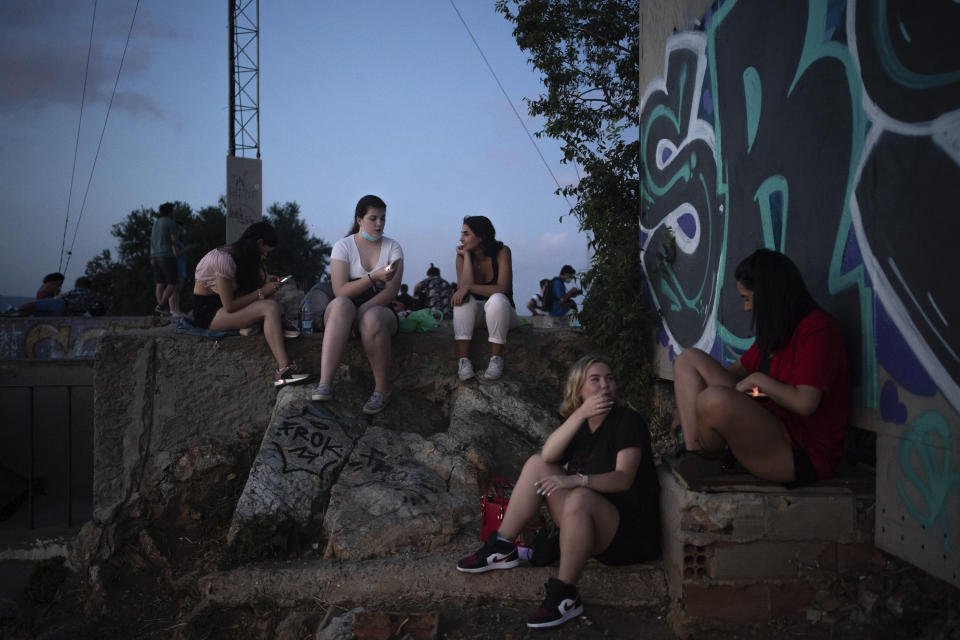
198;549;666;607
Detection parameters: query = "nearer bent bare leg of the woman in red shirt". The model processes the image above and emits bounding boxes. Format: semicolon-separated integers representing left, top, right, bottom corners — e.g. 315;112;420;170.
695;385;796;482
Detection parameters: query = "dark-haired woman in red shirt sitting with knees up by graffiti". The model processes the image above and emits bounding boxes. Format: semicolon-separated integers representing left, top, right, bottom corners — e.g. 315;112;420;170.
673;249;850;485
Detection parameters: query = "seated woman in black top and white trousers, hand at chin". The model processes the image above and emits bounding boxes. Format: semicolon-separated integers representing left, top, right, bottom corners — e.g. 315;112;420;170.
450;216;520;380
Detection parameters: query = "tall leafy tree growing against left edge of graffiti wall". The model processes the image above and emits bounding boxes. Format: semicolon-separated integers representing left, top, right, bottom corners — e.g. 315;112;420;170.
496;0;654;400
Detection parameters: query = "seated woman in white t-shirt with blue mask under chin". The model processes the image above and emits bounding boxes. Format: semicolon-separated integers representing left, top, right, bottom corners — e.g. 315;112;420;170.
311;195;403;415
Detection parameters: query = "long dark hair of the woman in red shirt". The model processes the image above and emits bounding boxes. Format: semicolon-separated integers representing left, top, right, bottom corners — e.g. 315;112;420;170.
734;249;820;358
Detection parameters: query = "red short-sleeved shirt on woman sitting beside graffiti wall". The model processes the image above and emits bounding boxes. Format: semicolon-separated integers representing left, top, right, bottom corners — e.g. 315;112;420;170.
740;310;850;478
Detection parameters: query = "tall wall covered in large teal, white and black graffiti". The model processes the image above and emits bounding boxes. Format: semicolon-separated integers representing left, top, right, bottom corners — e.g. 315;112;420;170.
640;0;960;584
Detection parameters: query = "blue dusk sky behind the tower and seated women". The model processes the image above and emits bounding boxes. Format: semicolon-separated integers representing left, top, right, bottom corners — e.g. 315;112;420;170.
0;0;589;313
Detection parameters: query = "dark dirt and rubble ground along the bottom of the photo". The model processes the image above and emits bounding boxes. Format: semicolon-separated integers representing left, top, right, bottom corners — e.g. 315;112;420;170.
0;430;960;640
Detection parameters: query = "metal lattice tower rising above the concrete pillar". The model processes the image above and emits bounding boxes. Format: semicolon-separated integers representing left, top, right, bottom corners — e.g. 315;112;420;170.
229;0;260;158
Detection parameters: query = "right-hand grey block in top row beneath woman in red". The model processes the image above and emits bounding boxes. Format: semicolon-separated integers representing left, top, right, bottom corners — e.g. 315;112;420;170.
764;494;857;542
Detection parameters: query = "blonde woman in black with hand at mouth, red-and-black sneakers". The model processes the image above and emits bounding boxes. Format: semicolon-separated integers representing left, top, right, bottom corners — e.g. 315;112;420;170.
457;355;660;628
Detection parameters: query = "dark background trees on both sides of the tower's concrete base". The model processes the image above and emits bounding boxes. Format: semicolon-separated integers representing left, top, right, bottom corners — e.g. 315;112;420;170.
85;198;330;315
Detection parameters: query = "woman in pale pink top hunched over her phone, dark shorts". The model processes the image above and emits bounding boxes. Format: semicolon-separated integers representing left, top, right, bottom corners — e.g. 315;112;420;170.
193;222;310;386
